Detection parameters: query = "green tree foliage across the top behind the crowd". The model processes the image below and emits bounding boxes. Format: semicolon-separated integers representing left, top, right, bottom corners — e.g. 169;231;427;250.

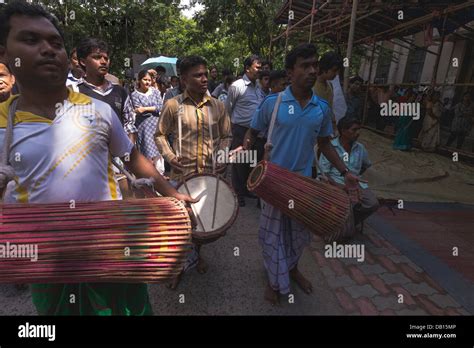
17;0;363;77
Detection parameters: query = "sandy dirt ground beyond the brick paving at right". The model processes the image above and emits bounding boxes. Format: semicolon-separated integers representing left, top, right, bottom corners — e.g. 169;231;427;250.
359;129;474;204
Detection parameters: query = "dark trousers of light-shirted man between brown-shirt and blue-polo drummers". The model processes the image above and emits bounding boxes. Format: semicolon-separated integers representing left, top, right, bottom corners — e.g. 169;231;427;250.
231;124;265;197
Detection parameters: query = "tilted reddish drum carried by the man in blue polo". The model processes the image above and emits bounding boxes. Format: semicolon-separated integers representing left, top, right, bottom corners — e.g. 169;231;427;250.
247;161;351;242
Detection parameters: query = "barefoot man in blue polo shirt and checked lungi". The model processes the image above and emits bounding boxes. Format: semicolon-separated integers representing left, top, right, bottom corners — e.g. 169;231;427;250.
243;44;357;304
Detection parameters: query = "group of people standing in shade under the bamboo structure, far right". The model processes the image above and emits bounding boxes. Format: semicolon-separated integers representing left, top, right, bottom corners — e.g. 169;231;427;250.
362;81;474;152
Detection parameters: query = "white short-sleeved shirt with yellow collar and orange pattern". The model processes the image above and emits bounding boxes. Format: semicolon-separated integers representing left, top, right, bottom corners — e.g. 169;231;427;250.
0;91;133;203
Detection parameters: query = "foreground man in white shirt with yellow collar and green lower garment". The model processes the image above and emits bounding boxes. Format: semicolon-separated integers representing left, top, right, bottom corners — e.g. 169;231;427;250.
0;2;196;315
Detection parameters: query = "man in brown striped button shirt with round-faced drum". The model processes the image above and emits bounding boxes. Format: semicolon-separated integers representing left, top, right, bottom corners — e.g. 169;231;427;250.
155;56;232;288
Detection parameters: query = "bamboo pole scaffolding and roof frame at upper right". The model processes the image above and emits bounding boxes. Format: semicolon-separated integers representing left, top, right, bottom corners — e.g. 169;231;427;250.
271;0;474;154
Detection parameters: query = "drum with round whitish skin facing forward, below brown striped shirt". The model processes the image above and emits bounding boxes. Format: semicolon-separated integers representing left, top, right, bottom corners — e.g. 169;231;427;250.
177;174;239;244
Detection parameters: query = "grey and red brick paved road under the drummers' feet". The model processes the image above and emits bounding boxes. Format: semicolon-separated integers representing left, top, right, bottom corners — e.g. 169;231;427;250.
0;201;474;315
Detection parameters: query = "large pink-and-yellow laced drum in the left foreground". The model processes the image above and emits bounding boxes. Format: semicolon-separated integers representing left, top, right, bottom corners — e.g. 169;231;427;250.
0;197;192;284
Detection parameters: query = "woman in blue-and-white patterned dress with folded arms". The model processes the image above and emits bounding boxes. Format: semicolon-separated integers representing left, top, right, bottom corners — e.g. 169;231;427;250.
127;70;165;175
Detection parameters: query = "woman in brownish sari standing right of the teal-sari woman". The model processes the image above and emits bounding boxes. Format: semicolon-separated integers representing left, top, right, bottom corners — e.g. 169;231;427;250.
418;91;443;152
